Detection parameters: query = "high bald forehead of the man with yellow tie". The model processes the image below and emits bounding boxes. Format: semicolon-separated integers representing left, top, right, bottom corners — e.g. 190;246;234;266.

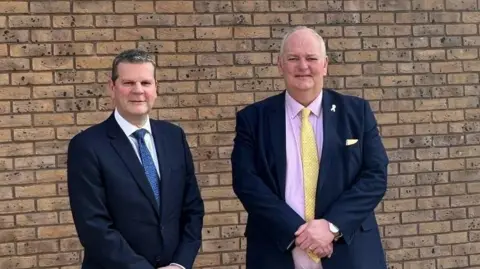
284;31;321;54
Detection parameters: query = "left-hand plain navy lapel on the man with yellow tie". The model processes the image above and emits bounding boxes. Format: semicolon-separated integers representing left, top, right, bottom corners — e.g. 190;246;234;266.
268;93;287;198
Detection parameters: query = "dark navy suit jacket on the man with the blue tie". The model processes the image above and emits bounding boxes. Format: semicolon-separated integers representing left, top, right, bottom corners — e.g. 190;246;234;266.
67;114;204;269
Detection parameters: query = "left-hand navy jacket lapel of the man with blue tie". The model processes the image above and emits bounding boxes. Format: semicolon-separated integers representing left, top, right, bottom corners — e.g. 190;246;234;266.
107;114;159;216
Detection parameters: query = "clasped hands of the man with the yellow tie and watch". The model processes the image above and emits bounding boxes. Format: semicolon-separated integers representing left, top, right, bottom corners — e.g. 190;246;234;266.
295;219;334;258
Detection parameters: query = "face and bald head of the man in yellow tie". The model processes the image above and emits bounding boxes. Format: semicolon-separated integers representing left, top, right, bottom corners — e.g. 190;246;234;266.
278;30;328;93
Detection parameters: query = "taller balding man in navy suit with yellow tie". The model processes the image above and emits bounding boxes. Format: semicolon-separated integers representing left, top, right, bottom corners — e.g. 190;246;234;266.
231;27;388;269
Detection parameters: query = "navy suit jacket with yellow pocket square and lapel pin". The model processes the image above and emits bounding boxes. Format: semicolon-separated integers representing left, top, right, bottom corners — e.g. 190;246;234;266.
232;89;388;269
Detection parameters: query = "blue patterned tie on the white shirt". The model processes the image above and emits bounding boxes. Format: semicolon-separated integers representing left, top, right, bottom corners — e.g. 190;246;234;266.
133;129;160;204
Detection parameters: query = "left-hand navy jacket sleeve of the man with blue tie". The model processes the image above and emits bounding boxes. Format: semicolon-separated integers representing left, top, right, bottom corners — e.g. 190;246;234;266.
67;136;154;269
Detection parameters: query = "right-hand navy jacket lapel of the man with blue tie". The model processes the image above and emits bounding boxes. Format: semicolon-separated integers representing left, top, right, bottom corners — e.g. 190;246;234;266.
150;120;175;221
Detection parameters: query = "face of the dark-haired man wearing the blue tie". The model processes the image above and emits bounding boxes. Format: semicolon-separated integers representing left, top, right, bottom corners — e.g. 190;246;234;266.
110;63;157;122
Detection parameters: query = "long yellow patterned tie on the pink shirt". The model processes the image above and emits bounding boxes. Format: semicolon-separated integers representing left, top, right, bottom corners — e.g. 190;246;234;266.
301;108;320;263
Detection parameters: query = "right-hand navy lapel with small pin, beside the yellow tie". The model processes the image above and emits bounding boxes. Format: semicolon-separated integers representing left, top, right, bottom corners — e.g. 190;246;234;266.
316;90;341;209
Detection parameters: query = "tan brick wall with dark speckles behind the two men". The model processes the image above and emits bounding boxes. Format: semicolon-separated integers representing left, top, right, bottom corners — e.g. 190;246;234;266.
0;0;480;269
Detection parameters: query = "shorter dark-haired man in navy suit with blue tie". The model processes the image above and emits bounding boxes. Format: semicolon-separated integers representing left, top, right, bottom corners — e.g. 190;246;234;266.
67;49;204;269
